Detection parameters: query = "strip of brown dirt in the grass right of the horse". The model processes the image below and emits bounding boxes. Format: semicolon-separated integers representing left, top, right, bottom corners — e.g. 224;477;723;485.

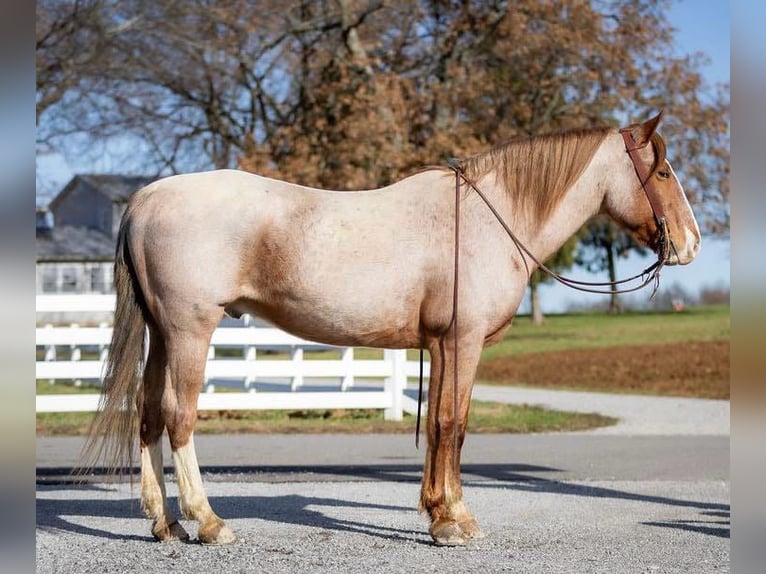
477;341;729;399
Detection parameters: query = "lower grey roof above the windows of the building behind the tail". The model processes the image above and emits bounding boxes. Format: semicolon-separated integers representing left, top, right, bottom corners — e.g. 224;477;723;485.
36;225;115;263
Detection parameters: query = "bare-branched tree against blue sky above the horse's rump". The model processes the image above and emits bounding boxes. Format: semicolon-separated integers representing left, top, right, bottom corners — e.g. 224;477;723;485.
38;0;308;172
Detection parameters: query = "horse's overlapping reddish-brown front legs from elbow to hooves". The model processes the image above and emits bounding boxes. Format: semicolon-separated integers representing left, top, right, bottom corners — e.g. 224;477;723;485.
420;339;484;546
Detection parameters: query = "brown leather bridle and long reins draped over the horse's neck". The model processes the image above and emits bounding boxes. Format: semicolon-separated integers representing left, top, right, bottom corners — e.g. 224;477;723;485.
415;128;674;452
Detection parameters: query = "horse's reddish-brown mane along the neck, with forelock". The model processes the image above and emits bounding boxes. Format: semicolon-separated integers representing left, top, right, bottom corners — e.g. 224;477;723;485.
460;124;666;223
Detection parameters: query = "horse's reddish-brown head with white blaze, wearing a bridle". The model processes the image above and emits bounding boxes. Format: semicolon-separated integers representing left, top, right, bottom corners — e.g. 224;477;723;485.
602;112;700;265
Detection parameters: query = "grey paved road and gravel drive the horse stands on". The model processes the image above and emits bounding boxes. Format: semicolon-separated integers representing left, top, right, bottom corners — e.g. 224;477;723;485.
37;388;730;573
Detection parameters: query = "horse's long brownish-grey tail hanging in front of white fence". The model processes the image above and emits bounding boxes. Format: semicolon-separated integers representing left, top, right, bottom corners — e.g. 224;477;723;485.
79;209;146;482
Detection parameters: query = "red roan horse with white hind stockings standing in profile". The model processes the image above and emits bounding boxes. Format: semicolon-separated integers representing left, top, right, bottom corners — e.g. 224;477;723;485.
85;114;700;545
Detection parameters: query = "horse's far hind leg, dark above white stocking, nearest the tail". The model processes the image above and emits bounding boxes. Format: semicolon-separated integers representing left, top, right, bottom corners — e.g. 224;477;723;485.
140;329;189;542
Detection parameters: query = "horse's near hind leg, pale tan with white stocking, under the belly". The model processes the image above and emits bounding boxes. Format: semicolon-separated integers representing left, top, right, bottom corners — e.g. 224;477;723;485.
162;320;236;544
